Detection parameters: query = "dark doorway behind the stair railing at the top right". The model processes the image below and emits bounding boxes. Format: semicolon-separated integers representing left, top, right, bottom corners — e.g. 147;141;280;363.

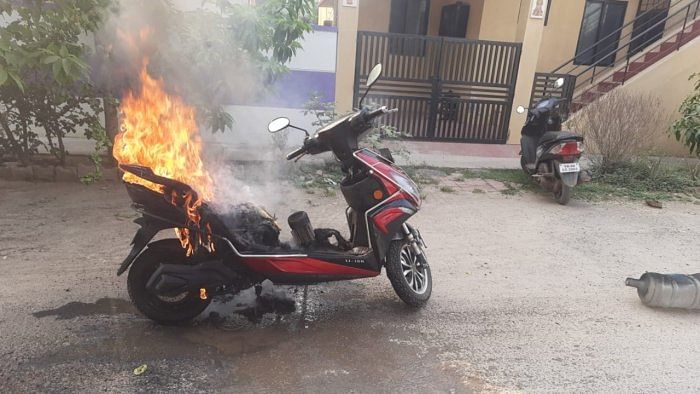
628;0;671;57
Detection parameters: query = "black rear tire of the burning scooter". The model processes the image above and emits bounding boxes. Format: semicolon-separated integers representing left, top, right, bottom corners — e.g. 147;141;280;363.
127;239;211;325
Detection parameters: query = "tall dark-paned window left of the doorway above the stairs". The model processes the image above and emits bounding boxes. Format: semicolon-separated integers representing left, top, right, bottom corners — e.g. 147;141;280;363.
574;0;627;66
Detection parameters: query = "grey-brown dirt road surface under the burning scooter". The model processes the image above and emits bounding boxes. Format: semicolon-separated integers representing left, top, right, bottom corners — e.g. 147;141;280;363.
0;181;700;393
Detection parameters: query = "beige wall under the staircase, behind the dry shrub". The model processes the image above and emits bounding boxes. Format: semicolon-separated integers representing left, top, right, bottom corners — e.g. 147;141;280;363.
618;39;700;156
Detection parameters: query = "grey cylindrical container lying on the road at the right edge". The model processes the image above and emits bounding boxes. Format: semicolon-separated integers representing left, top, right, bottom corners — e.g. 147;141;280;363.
625;272;700;309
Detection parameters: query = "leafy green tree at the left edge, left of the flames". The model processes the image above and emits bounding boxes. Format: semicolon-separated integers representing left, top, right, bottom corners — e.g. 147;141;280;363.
0;0;110;164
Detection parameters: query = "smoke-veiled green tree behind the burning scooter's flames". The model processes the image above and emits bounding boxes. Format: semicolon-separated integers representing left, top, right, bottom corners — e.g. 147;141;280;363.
95;0;315;140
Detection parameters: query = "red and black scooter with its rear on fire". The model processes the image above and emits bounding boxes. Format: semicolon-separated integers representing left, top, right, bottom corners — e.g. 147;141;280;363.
115;65;432;324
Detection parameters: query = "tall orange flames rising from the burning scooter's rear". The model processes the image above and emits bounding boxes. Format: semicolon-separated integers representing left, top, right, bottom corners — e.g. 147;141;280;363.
113;61;212;255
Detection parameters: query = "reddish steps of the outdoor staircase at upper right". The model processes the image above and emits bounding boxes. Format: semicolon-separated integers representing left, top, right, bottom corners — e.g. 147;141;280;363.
570;18;700;113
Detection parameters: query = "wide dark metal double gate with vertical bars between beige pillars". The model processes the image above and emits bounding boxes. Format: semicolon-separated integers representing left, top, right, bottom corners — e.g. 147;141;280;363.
354;31;521;144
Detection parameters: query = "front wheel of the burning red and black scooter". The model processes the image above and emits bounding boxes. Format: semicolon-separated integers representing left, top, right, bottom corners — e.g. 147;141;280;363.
386;240;433;307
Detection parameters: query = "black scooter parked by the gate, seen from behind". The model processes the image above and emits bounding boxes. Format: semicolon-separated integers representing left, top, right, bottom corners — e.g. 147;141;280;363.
516;79;583;205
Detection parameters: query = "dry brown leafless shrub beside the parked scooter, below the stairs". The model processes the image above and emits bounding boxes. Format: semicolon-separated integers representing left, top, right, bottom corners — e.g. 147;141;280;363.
569;90;665;172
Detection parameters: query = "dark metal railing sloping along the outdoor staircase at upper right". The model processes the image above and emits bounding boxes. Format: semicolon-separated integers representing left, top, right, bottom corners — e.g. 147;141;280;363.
531;0;700;113
